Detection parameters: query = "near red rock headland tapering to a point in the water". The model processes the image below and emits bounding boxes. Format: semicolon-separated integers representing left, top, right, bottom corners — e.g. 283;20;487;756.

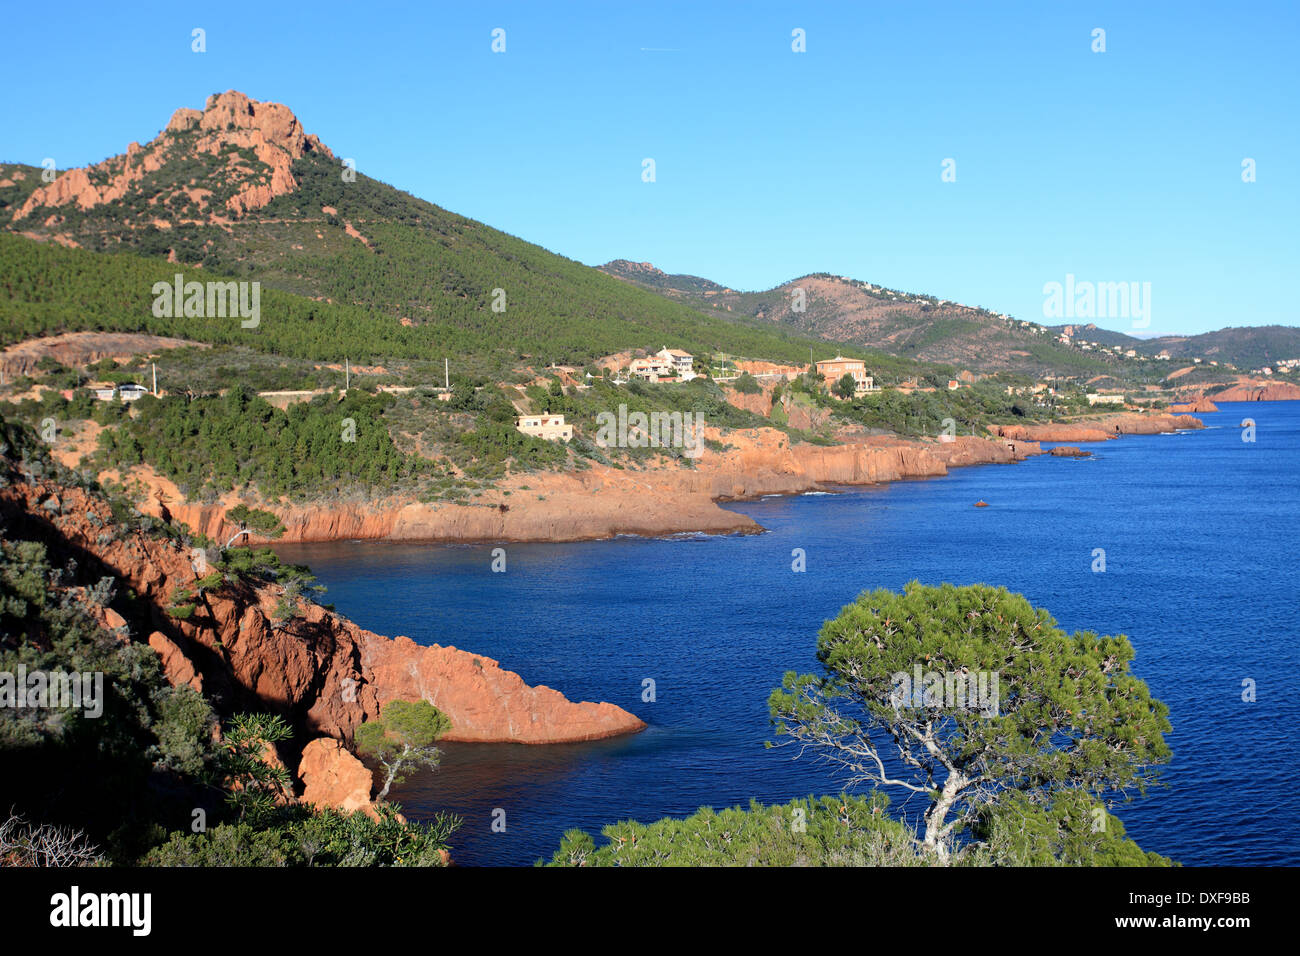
0;470;645;744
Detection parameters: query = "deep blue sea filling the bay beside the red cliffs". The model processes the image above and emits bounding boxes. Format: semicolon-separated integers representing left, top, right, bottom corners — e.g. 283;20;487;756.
278;402;1300;865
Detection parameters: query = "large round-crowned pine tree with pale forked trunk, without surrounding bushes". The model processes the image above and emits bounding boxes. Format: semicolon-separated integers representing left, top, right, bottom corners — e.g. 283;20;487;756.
770;581;1171;860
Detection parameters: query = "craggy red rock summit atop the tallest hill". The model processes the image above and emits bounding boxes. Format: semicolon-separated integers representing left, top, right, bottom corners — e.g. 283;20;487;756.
13;90;333;225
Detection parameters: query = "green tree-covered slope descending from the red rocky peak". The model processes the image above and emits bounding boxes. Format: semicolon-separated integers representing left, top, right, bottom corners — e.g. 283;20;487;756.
0;156;904;375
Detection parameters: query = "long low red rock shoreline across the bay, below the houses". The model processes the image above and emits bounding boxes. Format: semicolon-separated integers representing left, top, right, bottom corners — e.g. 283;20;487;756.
109;415;1203;542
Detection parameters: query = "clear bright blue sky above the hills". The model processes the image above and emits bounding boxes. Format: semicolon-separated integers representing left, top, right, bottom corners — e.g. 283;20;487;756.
0;0;1300;334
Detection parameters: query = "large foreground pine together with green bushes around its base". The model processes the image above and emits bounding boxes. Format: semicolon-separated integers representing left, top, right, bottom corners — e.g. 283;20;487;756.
540;583;1171;866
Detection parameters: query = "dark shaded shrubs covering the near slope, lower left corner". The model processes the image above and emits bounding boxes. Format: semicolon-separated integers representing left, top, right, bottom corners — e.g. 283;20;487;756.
0;419;459;866
